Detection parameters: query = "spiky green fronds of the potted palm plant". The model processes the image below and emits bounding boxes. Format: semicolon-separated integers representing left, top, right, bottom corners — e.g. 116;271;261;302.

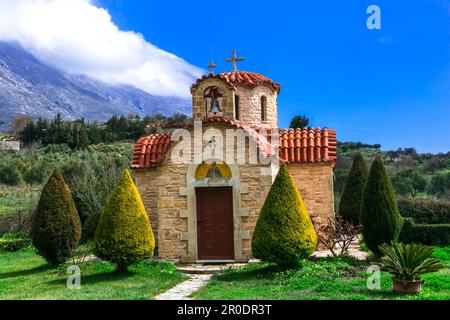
380;243;444;281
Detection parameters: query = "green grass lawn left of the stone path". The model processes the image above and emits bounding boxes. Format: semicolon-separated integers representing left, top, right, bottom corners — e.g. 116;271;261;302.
0;249;187;300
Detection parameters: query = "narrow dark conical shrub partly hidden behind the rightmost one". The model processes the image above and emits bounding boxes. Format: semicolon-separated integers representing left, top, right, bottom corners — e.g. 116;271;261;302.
338;152;369;226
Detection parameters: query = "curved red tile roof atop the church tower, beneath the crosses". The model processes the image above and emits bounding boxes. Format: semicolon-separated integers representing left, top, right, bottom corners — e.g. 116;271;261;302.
191;71;281;93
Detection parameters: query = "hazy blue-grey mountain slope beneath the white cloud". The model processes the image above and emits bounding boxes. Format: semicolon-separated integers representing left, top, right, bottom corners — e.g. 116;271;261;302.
0;42;191;131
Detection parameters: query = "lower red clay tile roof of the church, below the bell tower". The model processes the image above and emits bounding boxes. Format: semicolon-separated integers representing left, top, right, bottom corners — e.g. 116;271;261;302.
131;116;337;169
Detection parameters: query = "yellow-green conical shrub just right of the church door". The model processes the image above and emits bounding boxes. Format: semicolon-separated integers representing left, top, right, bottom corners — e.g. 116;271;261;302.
252;165;317;268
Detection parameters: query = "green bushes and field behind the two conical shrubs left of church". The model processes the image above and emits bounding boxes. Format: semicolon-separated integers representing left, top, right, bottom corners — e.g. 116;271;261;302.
0;142;133;239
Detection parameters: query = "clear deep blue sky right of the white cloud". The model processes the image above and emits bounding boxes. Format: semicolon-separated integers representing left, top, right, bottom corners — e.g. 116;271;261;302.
101;0;450;152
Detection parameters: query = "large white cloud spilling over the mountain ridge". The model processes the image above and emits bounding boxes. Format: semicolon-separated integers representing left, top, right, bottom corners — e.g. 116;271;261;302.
0;0;202;97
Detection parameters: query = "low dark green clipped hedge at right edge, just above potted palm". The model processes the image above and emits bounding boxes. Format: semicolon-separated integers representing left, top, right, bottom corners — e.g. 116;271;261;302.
399;218;450;246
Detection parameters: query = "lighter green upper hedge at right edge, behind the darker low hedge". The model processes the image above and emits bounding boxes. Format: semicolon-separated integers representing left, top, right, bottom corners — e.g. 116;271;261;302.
397;198;450;224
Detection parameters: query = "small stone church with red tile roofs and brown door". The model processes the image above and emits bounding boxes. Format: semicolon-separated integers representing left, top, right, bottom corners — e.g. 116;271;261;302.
132;52;336;262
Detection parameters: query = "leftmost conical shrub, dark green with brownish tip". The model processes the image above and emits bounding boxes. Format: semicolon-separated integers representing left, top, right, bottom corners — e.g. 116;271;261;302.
31;170;81;265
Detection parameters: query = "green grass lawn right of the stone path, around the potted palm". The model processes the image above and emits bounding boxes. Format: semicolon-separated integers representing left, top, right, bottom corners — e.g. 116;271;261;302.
194;247;450;300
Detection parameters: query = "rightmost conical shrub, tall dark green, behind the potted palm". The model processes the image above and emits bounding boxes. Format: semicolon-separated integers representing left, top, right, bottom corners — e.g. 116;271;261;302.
360;156;403;256
